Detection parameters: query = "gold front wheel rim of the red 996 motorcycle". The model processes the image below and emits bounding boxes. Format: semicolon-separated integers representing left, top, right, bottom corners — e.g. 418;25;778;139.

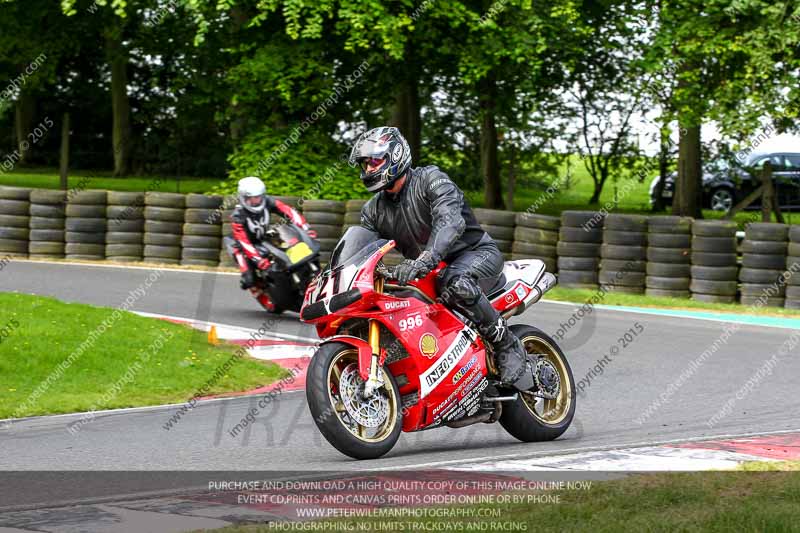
327;349;398;443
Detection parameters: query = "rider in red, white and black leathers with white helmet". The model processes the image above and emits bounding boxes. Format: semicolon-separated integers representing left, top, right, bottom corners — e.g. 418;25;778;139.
231;177;317;310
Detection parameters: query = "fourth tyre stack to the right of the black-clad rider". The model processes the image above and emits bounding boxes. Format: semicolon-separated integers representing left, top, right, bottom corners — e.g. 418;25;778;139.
599;215;647;294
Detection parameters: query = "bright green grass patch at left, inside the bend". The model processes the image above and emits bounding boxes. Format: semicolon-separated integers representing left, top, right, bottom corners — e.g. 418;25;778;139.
0;293;285;419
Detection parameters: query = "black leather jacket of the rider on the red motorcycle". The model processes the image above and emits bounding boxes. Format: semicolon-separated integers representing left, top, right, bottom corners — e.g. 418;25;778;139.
361;166;491;261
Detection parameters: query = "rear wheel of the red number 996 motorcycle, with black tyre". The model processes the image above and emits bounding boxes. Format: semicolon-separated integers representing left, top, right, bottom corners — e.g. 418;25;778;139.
500;324;576;442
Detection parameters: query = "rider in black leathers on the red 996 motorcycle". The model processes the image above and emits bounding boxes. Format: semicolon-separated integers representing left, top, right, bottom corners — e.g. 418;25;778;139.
350;127;534;390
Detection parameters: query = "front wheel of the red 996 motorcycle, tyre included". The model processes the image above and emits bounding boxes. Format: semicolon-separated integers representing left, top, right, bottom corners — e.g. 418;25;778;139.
306;342;403;459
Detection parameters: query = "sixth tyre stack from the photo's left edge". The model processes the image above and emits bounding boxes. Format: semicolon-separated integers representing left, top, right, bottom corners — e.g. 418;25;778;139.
181;194;223;266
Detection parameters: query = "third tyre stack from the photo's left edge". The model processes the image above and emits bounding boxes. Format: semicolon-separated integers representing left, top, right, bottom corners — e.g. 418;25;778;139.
64;190;108;261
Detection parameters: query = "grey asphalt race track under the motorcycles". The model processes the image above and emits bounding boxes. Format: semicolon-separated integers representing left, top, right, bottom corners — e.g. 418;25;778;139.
0;261;800;471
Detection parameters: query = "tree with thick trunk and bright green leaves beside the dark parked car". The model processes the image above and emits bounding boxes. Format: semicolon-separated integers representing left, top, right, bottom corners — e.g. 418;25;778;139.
649;0;798;216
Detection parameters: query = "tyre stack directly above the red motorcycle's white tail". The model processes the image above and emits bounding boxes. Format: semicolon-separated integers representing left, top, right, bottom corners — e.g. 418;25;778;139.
511;213;561;272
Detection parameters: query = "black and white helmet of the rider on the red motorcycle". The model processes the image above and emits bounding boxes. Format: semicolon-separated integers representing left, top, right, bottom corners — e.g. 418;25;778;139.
350;126;411;192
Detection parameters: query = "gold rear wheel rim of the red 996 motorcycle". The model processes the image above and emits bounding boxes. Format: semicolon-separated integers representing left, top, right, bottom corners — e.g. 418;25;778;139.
520;335;572;425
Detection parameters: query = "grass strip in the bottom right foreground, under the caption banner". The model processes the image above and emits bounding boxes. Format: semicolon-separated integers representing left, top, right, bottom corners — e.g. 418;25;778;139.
197;463;800;533
